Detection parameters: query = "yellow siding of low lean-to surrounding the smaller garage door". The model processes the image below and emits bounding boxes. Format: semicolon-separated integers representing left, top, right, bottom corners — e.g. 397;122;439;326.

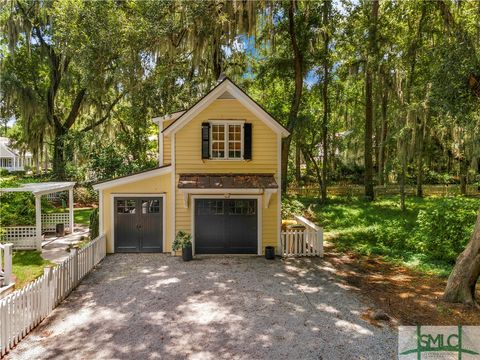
101;174;174;253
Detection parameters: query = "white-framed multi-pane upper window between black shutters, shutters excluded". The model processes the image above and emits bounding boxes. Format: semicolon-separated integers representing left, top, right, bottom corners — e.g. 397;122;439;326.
210;122;243;159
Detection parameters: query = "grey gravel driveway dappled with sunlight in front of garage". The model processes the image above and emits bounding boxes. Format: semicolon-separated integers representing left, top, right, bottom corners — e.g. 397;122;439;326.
8;254;397;360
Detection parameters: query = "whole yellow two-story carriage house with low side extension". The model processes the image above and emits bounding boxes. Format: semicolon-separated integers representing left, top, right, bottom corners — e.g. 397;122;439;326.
94;78;289;255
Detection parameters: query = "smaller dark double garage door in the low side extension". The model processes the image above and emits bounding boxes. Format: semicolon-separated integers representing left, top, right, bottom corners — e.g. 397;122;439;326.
114;197;163;252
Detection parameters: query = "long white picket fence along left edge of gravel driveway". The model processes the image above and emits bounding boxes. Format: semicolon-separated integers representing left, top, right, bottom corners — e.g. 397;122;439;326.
0;235;106;356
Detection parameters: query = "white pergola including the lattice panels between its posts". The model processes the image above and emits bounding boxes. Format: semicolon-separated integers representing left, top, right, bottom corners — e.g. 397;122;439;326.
0;182;75;250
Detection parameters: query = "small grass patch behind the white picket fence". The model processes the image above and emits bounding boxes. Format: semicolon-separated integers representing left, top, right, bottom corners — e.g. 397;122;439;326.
12;250;54;289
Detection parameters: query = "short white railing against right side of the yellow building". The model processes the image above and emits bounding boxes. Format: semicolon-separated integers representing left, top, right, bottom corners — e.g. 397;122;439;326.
282;216;323;257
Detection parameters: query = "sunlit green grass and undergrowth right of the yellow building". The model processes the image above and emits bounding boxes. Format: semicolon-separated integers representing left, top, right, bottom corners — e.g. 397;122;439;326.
290;196;480;276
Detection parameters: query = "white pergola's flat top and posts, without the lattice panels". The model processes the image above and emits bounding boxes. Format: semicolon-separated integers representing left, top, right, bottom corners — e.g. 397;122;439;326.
0;181;75;250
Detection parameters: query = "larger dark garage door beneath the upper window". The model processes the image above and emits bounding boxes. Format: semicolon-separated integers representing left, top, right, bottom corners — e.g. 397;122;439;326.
195;199;258;254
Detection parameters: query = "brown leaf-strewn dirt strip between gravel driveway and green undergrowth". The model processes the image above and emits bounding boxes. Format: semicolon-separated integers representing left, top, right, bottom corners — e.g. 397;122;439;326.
325;244;480;325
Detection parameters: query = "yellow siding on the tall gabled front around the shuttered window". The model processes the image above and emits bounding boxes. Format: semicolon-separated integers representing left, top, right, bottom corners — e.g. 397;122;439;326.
175;99;280;252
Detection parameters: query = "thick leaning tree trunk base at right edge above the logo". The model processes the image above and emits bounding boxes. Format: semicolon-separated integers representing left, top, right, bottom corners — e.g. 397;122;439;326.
443;212;480;305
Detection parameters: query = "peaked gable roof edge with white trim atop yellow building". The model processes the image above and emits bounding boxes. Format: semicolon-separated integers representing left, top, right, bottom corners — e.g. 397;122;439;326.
162;77;290;137
